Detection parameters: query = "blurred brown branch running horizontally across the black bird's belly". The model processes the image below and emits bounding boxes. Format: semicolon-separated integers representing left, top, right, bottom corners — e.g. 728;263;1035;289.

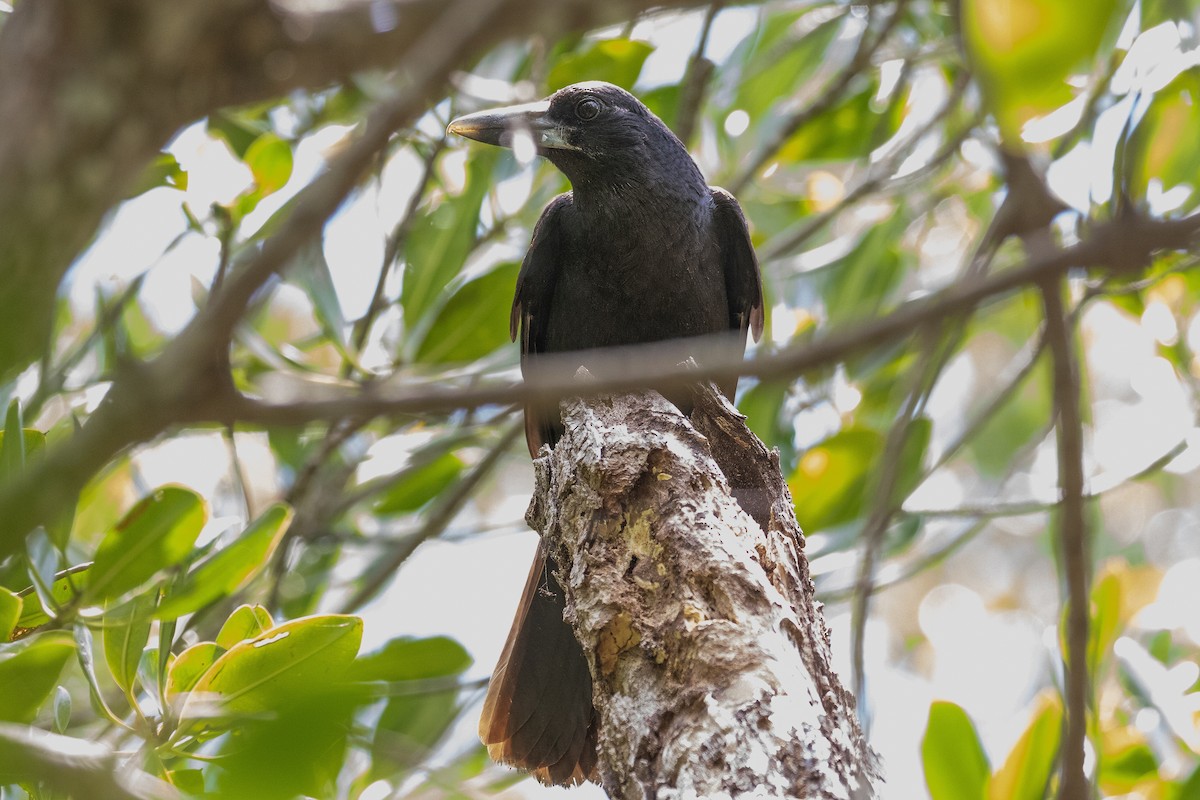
0;206;1200;558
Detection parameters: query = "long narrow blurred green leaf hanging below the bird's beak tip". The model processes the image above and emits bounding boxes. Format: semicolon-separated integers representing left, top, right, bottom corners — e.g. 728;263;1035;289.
400;148;498;330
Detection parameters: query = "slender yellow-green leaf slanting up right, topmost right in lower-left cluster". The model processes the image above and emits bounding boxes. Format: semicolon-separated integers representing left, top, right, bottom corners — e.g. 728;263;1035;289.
155;504;293;619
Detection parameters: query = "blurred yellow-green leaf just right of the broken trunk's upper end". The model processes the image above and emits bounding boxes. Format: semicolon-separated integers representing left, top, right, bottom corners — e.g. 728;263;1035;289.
787;428;883;533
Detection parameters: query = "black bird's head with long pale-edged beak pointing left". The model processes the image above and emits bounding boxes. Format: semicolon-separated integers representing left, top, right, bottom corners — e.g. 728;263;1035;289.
449;80;698;190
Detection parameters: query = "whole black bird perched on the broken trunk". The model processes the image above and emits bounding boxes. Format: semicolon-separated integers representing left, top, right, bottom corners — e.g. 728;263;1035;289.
448;82;763;784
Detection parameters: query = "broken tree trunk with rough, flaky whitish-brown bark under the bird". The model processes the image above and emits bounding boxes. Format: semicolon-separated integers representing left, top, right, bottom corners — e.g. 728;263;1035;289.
528;387;878;800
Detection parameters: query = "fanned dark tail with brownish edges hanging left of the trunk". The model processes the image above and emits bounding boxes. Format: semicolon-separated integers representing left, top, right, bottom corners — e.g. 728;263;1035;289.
479;546;596;784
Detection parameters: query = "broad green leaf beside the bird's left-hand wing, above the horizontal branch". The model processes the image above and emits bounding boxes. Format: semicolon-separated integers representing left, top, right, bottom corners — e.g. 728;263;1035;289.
416;264;521;363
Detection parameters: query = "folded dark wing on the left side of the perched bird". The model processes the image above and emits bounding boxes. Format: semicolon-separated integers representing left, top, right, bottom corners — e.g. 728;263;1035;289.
509;192;571;456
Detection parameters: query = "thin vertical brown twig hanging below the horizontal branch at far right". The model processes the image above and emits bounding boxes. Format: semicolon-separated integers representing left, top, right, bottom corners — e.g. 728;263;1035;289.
1042;278;1091;800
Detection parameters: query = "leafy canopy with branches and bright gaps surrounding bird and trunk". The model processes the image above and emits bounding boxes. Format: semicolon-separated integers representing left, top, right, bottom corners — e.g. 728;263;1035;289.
0;0;1200;800
